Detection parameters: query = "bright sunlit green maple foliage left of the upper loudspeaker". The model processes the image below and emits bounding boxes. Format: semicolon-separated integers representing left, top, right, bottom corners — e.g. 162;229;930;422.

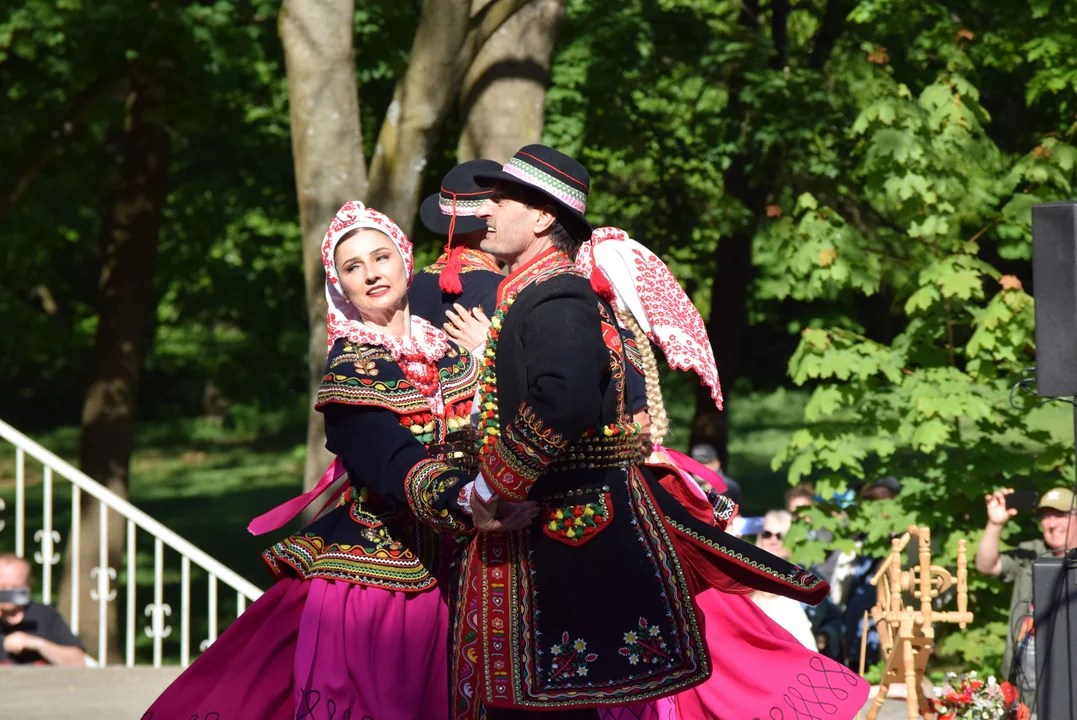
755;2;1077;667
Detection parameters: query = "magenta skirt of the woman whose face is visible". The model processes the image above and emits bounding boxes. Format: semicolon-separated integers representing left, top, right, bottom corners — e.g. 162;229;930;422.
142;578;449;720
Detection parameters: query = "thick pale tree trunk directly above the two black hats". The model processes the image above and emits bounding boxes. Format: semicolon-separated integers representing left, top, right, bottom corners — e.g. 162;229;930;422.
457;0;565;163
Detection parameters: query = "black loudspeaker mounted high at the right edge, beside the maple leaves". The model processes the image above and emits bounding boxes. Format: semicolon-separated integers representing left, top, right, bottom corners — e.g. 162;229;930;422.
1032;202;1077;397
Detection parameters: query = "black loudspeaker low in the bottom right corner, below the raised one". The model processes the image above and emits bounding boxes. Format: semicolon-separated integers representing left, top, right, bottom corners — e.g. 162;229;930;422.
1029;552;1077;720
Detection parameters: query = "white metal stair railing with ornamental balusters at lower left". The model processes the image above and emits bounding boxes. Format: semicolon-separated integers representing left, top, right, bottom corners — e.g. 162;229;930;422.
0;421;262;667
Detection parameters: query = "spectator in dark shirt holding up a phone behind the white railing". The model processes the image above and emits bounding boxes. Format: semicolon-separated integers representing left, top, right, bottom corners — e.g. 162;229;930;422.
0;553;86;667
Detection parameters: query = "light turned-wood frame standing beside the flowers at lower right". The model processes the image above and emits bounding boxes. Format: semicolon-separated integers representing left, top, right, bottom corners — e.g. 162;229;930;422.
861;526;973;720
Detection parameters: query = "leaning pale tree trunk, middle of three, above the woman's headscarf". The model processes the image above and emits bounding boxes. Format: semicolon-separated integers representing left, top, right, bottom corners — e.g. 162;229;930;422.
368;0;530;234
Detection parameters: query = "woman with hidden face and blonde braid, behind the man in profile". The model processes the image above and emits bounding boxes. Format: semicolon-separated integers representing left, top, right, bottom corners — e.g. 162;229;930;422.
576;227;869;720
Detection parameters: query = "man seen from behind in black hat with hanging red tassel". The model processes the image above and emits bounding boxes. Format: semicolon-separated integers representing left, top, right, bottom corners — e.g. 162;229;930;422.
408;160;505;331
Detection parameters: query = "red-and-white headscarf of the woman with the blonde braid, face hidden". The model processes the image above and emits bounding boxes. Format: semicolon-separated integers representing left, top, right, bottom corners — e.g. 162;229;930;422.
576;227;722;409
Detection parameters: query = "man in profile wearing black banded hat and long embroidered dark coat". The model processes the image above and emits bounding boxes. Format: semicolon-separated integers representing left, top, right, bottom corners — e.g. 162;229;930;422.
412;145;828;720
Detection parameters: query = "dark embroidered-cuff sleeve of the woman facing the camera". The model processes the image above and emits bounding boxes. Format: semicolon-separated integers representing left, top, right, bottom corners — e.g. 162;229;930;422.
322;403;471;533
